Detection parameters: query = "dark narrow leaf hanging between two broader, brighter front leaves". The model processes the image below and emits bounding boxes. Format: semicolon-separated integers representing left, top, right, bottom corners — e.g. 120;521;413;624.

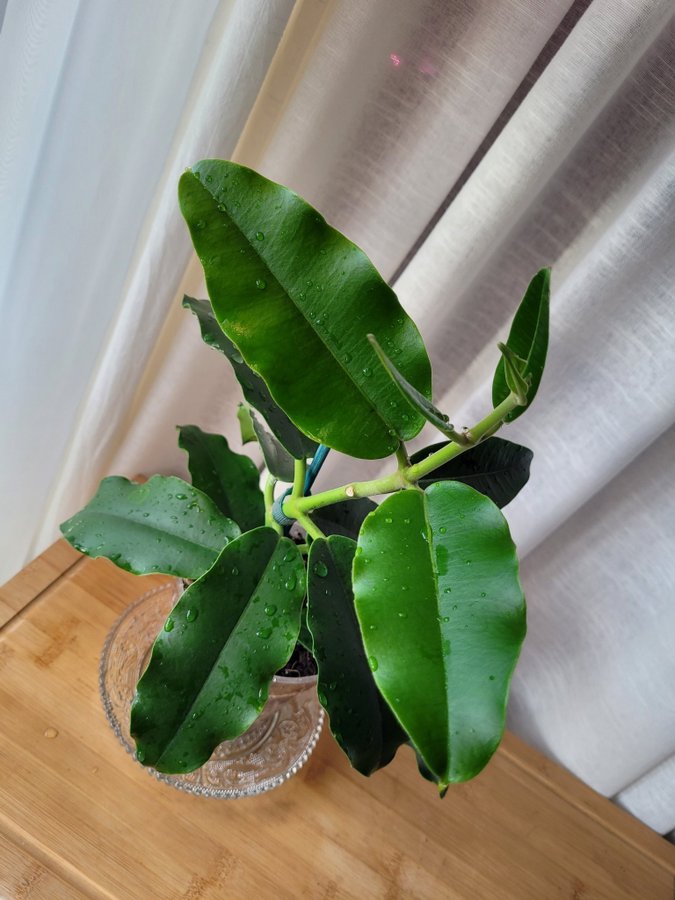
307;536;408;775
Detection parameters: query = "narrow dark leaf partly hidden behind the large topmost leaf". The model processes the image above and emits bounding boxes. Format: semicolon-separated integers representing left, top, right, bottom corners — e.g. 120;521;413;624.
183;296;317;459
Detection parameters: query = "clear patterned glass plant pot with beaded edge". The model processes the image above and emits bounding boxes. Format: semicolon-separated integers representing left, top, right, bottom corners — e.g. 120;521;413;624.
99;579;324;798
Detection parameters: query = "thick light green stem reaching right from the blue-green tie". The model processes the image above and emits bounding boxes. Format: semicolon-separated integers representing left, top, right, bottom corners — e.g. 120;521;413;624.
284;394;521;516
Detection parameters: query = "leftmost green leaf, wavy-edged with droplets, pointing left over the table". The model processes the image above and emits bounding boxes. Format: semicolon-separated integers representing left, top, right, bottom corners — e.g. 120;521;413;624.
61;475;240;579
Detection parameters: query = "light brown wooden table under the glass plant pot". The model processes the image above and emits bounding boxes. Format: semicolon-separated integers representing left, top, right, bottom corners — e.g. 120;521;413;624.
0;542;675;900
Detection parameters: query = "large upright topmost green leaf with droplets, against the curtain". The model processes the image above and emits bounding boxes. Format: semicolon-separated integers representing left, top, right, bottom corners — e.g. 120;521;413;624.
178;160;431;459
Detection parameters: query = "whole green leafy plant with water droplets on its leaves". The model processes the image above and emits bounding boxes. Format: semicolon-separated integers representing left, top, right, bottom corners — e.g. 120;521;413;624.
62;160;549;794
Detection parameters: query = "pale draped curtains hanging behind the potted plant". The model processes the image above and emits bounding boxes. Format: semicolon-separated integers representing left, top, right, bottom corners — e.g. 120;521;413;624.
0;0;675;833
